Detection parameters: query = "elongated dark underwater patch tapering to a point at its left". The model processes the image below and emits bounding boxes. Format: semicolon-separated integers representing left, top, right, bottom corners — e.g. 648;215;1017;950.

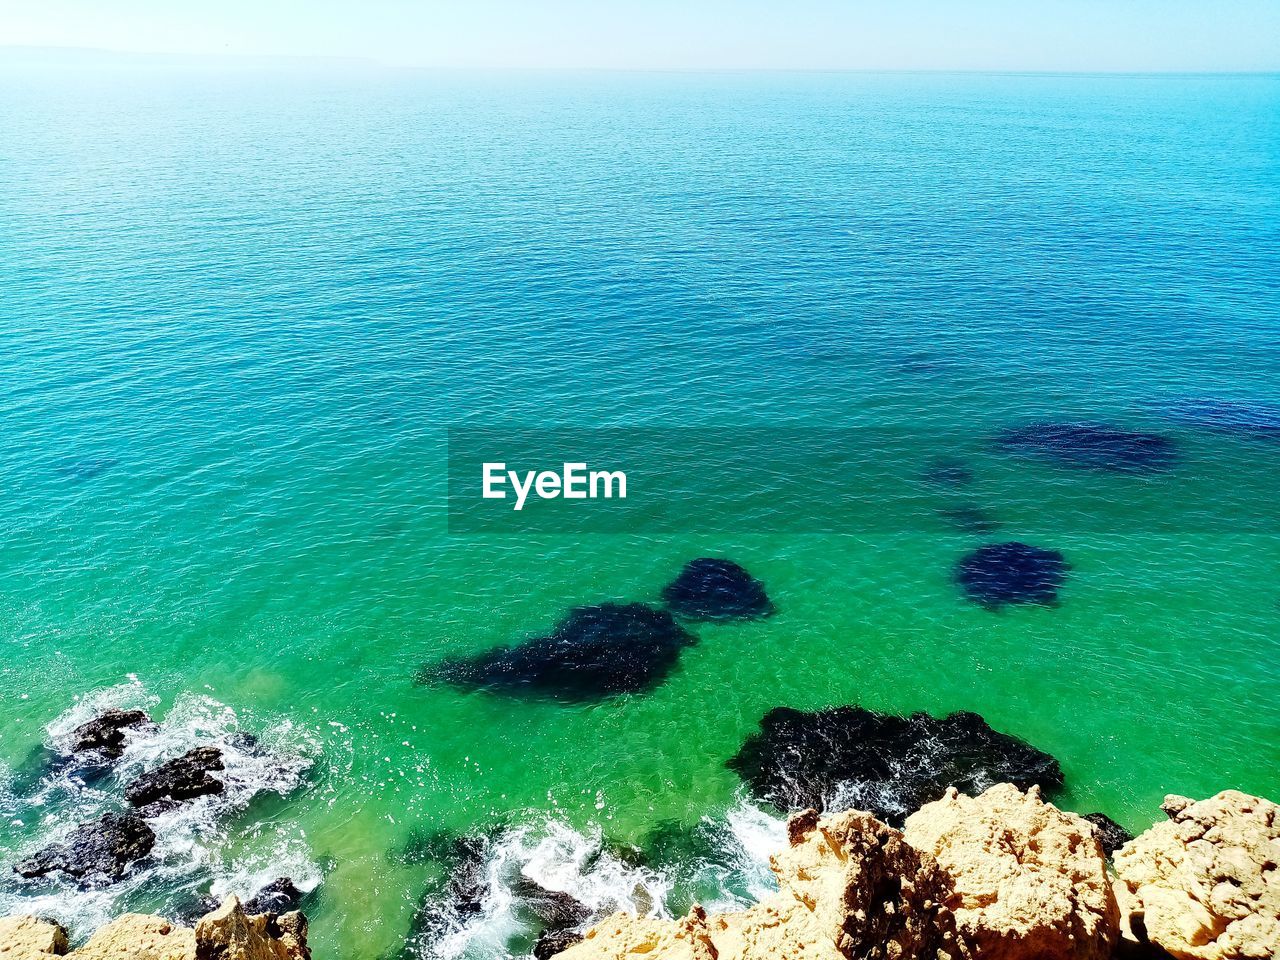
419;603;696;701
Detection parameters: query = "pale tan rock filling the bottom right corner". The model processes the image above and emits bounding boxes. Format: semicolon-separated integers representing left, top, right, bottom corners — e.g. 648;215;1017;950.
1115;790;1280;960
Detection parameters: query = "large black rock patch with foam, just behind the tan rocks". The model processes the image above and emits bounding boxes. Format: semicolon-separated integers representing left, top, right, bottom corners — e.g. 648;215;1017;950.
728;707;1062;824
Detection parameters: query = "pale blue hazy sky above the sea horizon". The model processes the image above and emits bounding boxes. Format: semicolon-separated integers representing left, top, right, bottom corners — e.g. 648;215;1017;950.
0;0;1280;70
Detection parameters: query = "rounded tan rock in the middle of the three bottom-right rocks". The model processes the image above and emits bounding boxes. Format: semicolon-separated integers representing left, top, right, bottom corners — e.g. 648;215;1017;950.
904;783;1119;960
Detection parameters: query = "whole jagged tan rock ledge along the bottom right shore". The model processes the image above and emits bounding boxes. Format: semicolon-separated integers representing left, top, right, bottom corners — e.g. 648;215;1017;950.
556;783;1280;960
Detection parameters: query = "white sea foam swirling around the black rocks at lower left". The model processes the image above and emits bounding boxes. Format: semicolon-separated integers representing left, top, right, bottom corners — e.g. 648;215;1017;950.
0;681;321;937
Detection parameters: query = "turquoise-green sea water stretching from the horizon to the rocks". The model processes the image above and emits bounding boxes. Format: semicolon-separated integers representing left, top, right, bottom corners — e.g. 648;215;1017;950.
0;70;1280;957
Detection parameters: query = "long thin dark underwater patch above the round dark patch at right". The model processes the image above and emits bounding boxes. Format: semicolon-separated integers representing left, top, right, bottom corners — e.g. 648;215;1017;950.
996;422;1178;474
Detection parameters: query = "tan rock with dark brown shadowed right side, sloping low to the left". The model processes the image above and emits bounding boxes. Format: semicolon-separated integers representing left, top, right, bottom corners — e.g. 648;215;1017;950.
559;810;963;960
